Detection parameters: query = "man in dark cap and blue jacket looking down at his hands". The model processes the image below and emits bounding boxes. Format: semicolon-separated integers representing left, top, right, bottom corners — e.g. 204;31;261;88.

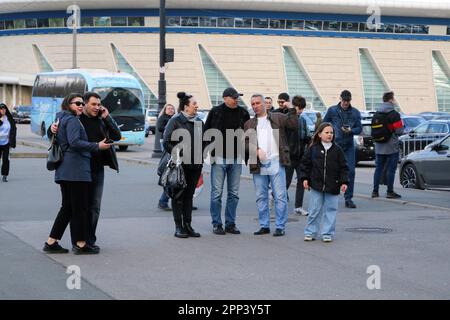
323;90;362;208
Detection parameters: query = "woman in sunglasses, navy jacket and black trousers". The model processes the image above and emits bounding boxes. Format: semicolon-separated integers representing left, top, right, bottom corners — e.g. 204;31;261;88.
43;93;110;254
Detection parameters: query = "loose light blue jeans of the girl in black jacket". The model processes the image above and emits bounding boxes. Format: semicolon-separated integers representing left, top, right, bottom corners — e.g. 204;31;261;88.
305;189;339;237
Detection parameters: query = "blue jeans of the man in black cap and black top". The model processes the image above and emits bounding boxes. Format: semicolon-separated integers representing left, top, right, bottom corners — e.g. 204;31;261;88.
210;163;242;227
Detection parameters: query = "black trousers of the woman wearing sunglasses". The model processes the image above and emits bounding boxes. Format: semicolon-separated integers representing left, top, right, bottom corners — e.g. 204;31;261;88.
50;181;89;242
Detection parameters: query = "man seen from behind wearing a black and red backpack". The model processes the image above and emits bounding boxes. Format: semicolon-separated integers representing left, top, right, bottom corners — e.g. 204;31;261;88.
372;91;404;199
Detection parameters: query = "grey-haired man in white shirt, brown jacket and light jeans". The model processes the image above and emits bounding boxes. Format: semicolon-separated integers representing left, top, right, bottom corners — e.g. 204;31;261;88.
244;94;298;237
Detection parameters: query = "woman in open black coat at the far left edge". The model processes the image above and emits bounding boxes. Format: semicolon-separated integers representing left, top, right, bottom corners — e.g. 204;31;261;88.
0;103;17;182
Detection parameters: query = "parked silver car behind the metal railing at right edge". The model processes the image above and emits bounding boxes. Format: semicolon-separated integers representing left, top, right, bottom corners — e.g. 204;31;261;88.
399;120;450;158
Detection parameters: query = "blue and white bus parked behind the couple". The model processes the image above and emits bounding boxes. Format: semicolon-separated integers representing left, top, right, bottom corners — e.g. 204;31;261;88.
31;69;145;150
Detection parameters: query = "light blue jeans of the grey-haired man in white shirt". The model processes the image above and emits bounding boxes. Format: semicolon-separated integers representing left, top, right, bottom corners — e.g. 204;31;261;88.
253;162;288;230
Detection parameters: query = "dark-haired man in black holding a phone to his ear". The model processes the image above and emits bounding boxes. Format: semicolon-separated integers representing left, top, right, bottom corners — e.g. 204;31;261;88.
50;92;122;250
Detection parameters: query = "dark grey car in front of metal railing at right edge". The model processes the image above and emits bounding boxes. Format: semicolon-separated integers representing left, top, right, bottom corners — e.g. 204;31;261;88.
399;134;450;189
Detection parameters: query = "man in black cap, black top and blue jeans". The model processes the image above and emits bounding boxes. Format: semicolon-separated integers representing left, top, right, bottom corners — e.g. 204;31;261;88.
205;88;250;235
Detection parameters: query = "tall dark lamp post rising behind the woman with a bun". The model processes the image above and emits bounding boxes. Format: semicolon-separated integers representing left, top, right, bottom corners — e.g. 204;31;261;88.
152;0;166;158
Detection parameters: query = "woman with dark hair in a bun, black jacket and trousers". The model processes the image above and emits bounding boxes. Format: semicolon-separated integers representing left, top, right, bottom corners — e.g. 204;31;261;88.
163;92;203;238
